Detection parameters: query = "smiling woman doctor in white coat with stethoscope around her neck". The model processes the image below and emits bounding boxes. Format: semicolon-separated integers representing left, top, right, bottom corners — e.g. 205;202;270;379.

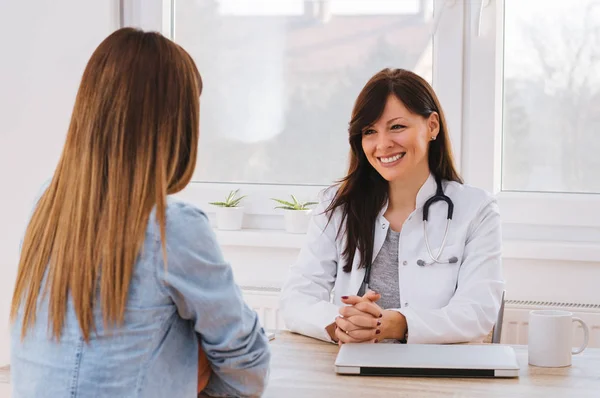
280;69;504;343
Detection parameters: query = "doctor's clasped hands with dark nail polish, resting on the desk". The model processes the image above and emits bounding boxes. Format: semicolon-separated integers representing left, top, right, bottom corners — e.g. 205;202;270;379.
329;291;406;345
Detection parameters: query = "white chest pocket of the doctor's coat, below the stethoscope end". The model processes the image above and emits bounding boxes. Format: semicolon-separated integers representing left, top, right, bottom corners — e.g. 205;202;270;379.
416;245;464;308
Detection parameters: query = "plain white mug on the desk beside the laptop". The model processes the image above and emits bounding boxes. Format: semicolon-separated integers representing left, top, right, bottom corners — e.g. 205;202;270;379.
527;310;589;368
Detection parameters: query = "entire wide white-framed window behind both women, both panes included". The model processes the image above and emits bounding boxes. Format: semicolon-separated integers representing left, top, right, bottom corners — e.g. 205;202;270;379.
126;0;600;236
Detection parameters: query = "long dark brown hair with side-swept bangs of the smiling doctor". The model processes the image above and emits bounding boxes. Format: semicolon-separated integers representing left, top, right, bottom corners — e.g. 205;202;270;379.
326;69;462;272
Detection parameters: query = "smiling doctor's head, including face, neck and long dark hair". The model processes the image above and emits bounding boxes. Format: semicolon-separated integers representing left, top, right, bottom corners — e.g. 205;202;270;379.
328;69;462;272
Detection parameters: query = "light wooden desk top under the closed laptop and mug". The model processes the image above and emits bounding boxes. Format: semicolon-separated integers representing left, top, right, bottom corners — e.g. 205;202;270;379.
264;332;600;398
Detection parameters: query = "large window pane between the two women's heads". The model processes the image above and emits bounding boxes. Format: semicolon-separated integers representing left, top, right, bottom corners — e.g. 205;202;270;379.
175;0;433;185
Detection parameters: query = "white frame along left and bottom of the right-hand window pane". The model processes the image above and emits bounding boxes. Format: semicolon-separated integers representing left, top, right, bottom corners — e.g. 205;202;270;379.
462;0;600;233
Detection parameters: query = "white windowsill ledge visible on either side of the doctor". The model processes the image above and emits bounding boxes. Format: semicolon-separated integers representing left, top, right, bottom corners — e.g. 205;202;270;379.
215;229;600;262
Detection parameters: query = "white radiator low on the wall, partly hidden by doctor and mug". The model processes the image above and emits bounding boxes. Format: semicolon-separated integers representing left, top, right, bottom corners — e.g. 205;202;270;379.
242;287;600;348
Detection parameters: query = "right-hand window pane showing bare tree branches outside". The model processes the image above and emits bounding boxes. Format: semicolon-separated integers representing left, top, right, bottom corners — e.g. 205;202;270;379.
502;0;600;193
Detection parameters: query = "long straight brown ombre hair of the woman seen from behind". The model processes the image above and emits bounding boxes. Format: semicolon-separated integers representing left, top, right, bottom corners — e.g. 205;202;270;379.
11;28;202;341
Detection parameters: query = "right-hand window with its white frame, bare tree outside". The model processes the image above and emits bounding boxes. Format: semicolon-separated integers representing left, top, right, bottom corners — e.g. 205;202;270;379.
462;0;600;233
